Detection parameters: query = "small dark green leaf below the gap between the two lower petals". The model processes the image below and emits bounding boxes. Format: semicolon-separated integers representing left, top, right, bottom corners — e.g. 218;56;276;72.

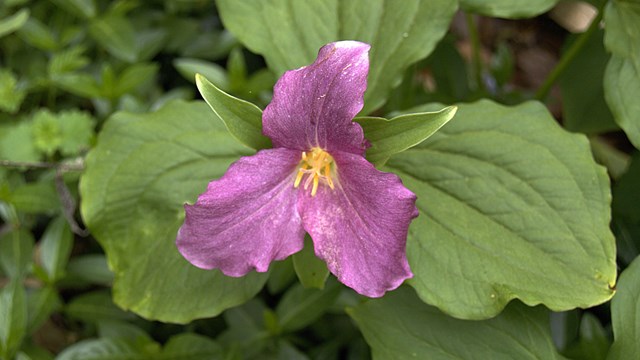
276;281;341;331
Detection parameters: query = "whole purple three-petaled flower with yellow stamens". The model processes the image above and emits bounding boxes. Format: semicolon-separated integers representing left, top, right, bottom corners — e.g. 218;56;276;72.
177;41;418;297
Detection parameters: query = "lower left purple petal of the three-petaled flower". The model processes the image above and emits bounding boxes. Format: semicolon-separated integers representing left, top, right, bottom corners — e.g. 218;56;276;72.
176;149;304;276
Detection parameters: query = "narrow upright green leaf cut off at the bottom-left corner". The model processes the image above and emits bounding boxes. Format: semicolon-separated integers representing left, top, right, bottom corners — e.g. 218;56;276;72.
0;279;27;359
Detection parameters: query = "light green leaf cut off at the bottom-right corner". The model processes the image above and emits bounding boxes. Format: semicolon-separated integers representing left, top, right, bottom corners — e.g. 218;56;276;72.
608;257;640;360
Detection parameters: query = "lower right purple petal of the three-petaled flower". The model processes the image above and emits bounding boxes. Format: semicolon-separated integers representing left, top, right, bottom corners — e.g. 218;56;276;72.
300;152;418;297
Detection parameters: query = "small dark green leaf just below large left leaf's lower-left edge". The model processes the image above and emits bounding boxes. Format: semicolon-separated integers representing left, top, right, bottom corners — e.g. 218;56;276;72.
65;290;135;323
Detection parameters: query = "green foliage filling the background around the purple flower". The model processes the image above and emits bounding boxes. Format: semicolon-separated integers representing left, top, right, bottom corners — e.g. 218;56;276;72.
0;0;640;359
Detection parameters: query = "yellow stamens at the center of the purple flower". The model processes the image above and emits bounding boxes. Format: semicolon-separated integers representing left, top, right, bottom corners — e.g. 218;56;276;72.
293;148;334;196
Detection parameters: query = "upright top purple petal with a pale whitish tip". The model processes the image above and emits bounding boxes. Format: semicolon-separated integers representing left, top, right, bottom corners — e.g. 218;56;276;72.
262;41;370;154
